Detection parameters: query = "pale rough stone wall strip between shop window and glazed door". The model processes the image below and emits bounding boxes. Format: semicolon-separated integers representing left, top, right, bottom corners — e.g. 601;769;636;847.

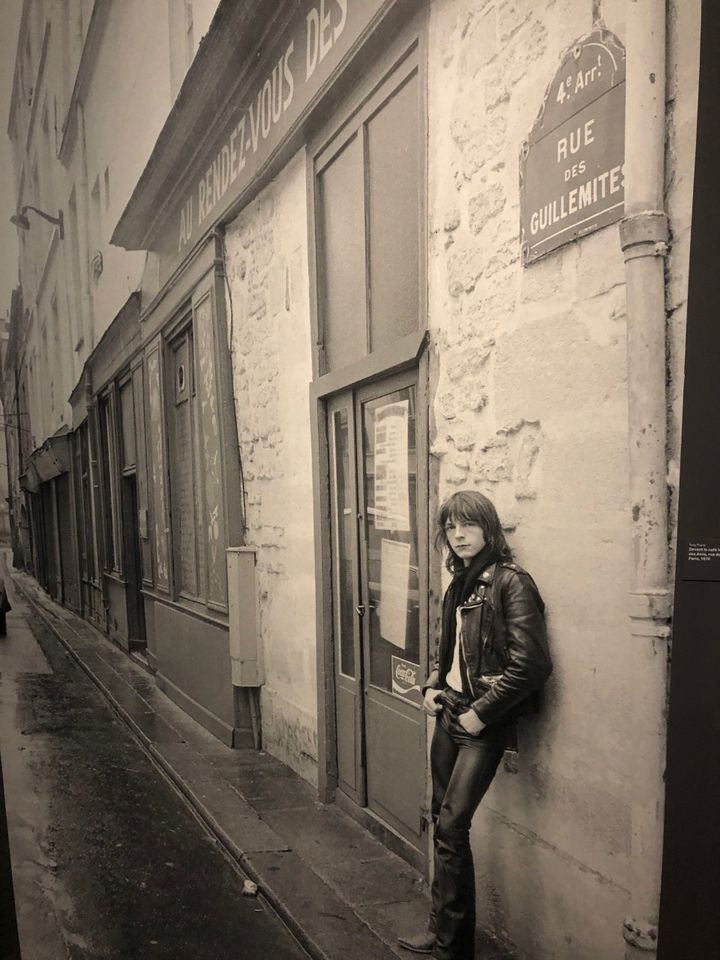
226;153;317;781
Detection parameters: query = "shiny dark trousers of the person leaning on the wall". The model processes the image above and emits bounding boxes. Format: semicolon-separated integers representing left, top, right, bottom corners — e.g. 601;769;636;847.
430;707;505;960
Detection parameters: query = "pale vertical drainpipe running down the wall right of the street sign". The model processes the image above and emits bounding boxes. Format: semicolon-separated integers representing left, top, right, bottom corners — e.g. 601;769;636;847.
620;0;671;960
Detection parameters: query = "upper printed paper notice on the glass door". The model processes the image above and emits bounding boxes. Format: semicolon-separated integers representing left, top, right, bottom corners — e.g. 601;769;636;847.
374;400;410;531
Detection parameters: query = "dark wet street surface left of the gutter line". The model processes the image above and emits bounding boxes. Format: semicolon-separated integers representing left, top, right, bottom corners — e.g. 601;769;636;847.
0;562;306;960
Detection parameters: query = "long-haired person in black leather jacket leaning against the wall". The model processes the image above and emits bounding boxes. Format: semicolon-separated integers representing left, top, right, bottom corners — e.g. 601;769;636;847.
398;490;552;960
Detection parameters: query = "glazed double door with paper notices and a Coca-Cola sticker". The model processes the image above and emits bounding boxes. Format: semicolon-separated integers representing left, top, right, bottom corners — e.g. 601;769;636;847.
328;371;427;848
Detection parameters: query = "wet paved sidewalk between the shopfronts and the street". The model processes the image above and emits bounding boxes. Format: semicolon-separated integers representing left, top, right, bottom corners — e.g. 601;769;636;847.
11;571;428;960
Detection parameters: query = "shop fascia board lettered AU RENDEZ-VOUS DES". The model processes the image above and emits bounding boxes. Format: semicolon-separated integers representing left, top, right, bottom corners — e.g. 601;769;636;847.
176;0;376;258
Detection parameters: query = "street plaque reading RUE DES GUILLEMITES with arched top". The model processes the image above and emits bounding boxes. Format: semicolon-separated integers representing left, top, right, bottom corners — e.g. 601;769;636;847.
520;31;625;264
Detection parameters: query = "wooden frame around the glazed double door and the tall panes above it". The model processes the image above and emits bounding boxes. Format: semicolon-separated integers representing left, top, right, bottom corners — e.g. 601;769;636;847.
306;2;431;872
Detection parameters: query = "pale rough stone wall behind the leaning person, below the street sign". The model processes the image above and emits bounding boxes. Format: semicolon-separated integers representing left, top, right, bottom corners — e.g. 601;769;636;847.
429;0;648;960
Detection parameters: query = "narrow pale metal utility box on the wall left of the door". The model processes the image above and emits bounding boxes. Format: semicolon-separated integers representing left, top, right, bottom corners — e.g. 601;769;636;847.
226;547;263;687
